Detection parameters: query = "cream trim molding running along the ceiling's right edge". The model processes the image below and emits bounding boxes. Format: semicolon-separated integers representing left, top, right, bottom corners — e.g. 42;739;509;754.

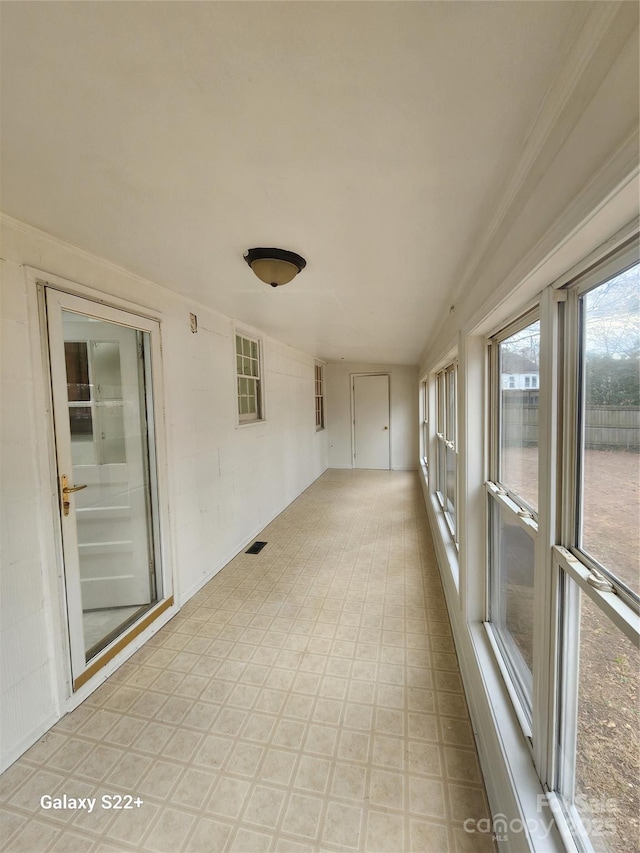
452;0;624;310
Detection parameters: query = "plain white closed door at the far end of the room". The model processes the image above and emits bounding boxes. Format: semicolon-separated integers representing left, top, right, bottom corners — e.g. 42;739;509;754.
353;374;391;470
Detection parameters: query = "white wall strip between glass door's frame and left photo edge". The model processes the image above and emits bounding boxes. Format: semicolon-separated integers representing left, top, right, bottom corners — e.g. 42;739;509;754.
0;261;56;766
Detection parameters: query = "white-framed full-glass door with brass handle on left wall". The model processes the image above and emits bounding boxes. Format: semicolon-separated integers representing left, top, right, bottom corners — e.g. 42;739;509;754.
46;288;169;683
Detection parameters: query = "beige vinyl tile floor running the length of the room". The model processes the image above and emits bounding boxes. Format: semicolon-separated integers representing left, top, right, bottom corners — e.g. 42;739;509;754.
0;470;494;853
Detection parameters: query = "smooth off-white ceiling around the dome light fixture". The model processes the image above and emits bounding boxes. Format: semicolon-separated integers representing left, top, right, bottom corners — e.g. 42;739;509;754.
1;0;590;364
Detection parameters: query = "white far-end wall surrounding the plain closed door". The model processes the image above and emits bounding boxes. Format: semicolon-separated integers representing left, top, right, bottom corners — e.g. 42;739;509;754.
325;361;418;470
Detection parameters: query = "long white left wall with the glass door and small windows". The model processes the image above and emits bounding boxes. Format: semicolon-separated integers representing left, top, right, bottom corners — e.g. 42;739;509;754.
0;217;327;769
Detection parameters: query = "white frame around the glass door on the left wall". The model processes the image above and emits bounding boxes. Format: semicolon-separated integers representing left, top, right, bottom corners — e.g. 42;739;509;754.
25;267;178;704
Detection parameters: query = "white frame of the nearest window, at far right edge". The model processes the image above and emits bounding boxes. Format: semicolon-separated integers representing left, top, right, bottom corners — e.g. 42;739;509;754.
547;236;640;853
